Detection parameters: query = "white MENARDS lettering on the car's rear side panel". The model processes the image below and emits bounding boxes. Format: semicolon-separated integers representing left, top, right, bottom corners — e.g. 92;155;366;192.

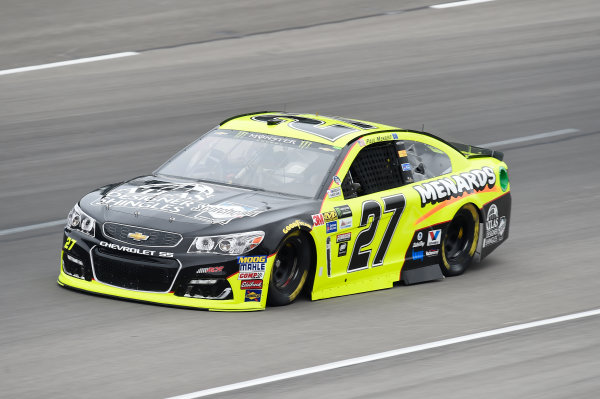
413;166;496;207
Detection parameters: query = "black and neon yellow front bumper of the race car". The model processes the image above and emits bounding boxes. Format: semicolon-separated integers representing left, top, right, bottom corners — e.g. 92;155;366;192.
57;230;274;311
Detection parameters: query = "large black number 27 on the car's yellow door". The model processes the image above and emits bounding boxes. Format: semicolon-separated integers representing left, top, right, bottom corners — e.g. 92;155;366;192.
348;194;406;273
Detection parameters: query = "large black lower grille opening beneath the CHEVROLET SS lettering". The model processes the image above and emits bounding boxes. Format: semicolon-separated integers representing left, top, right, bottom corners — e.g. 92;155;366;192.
92;248;180;292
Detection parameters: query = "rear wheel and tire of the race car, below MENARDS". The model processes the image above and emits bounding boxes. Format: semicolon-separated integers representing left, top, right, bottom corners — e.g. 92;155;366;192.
441;204;479;277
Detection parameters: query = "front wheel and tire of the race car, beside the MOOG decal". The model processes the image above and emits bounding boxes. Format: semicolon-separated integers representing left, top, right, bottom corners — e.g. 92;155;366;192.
267;231;311;306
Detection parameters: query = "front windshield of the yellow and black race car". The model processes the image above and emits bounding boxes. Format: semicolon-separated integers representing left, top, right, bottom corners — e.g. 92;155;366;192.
157;129;340;197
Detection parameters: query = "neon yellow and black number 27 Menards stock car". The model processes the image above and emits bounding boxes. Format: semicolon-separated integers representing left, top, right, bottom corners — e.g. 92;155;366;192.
58;112;511;310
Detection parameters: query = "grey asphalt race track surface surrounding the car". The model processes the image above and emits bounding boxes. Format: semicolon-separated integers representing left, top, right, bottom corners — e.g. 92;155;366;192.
0;0;600;399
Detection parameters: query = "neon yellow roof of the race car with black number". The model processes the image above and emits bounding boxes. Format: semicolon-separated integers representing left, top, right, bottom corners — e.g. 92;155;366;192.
219;111;400;147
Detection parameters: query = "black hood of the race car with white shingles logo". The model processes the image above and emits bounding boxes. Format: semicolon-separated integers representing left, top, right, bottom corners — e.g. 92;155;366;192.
81;176;315;238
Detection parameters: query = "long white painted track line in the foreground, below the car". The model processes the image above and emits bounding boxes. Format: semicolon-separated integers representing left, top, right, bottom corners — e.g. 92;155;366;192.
168;309;600;399
